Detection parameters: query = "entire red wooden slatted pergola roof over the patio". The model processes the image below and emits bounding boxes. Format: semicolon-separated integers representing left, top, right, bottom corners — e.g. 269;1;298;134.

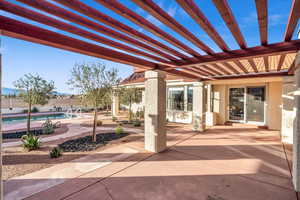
0;0;300;80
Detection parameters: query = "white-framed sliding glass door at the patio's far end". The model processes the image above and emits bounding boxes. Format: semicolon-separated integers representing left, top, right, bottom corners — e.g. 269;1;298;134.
229;86;266;124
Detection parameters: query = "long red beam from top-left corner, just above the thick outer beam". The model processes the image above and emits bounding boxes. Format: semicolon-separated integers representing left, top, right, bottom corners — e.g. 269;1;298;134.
0;1;171;64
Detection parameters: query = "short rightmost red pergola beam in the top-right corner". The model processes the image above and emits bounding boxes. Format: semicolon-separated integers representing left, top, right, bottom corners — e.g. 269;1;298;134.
284;0;300;41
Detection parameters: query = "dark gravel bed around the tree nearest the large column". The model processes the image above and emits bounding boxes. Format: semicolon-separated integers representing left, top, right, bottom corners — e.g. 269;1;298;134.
58;133;129;152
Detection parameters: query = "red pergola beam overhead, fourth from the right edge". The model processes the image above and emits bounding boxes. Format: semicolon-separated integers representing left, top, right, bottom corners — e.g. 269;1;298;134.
176;0;229;51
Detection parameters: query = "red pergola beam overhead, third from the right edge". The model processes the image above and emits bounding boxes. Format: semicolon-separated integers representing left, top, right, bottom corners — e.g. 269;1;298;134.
213;0;247;49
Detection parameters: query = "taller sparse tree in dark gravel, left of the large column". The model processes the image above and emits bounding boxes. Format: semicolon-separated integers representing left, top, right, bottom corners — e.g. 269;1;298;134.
68;63;120;142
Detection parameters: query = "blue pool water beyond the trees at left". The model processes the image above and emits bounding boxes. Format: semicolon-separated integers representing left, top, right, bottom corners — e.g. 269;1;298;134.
2;113;76;124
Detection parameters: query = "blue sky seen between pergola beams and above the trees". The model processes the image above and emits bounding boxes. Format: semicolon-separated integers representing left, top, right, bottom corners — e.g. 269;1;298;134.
0;0;299;93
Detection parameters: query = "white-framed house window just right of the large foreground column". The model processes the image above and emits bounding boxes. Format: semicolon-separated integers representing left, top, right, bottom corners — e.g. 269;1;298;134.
168;87;184;111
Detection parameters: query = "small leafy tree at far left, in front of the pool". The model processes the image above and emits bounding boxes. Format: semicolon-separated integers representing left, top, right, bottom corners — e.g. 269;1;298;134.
14;74;54;133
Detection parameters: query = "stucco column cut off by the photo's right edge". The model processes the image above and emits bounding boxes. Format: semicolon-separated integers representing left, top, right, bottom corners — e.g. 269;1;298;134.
293;51;300;192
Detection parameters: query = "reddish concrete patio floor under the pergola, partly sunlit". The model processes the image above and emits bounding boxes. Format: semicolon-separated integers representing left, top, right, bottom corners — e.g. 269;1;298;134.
13;126;297;200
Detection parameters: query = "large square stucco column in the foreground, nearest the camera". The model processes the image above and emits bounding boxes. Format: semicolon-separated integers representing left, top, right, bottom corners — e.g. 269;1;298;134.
145;71;167;152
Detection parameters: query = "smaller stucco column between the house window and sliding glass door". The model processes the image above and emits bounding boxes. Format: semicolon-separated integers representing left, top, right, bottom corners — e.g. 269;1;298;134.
193;82;205;132
